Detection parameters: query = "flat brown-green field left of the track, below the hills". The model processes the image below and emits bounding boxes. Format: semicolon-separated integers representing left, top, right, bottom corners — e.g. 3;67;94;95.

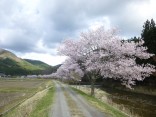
0;78;50;115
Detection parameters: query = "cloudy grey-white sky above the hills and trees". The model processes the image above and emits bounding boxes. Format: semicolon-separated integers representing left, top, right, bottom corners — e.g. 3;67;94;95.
0;0;156;65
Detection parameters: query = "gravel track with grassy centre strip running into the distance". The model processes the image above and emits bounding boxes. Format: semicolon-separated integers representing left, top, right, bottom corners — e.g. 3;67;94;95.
50;82;106;117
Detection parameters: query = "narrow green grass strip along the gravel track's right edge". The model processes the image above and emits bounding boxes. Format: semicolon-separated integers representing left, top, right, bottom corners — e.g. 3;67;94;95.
72;87;128;117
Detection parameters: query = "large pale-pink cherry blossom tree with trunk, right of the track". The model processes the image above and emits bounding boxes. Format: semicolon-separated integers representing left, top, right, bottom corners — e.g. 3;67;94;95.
59;27;155;95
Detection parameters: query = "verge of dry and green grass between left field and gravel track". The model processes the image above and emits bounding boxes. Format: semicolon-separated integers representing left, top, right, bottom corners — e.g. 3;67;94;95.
3;81;55;117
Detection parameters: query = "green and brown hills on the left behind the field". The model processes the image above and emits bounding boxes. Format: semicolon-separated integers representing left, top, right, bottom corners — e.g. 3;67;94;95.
0;49;56;75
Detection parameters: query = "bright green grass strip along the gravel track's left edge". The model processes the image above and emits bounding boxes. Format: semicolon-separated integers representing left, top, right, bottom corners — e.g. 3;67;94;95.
30;87;55;117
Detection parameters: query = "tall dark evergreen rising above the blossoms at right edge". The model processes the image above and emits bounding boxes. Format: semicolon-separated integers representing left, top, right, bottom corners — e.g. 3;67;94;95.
141;19;156;54
